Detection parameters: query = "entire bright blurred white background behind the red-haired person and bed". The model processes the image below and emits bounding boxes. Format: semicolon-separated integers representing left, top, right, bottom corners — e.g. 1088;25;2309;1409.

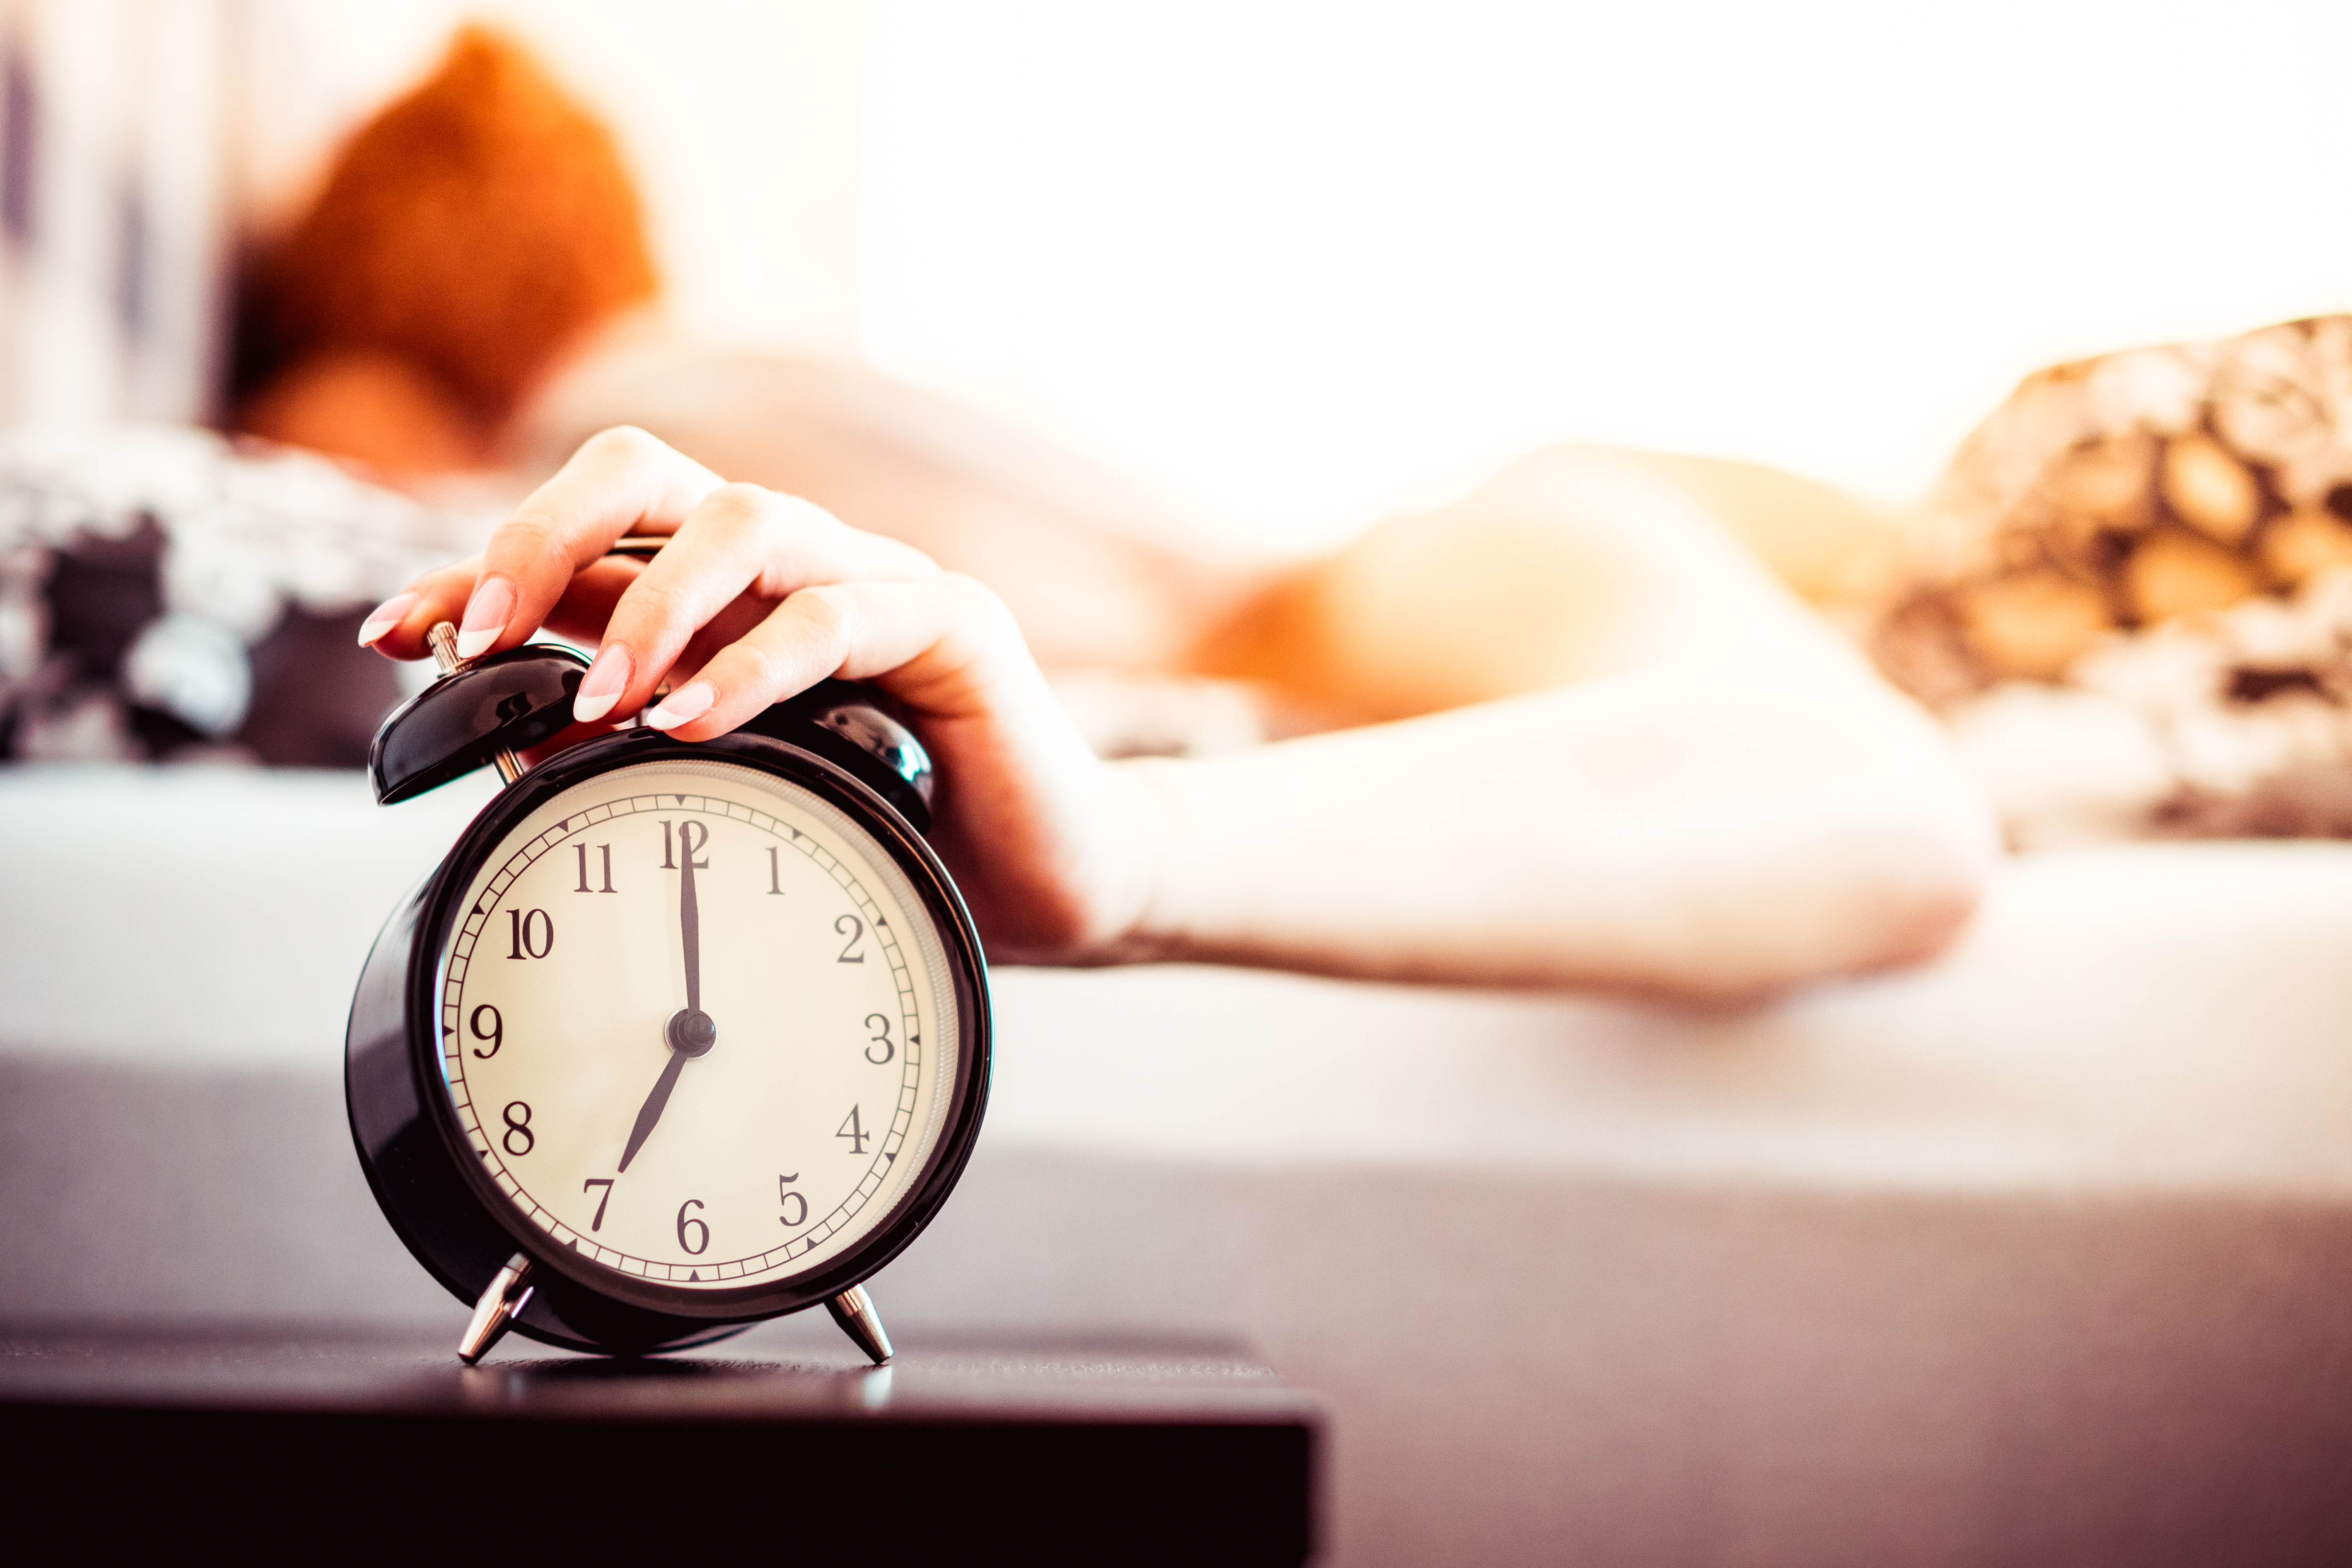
14;0;2352;564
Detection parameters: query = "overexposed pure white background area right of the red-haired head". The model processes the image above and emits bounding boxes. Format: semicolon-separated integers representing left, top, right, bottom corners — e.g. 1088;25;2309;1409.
861;0;2352;543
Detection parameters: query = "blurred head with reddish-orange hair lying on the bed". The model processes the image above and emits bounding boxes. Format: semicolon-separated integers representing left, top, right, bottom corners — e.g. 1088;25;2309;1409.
238;28;656;470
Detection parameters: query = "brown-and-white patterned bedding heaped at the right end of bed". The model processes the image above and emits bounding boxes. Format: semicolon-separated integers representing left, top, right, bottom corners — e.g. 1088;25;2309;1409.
1872;315;2352;846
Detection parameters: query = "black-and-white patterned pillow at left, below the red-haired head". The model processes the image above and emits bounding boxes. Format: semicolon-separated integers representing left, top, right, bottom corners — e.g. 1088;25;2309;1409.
0;425;492;766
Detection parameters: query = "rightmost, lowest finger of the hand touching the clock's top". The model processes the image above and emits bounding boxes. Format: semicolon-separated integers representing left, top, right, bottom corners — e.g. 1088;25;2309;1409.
644;576;1044;740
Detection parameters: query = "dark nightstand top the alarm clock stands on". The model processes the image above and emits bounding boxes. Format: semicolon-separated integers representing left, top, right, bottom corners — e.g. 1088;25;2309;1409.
0;1323;1322;1563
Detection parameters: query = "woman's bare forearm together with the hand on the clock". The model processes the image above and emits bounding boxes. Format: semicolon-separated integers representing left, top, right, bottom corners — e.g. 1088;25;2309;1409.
365;430;1990;995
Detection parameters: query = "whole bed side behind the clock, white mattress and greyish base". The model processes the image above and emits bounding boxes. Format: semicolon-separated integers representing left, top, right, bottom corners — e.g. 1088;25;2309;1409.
0;764;2352;1566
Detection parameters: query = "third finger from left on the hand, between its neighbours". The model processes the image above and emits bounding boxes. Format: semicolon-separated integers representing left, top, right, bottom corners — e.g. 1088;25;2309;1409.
581;484;938;717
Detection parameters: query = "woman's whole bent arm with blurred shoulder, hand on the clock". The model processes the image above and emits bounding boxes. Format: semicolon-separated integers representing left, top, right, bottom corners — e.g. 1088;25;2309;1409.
362;416;1994;997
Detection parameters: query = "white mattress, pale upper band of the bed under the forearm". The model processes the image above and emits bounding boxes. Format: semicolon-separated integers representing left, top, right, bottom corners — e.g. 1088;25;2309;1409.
18;769;2352;1199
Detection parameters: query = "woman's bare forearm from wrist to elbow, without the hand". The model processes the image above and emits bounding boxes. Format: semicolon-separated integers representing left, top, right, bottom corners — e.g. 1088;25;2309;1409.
1110;670;1992;995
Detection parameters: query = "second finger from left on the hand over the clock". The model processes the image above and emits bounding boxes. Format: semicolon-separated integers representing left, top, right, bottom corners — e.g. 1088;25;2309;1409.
456;425;722;658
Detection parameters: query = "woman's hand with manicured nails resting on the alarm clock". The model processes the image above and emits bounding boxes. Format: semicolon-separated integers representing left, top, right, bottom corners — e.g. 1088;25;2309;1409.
360;428;1160;964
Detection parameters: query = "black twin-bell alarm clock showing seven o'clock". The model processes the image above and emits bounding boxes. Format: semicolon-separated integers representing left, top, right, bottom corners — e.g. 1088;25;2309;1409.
346;557;990;1361
